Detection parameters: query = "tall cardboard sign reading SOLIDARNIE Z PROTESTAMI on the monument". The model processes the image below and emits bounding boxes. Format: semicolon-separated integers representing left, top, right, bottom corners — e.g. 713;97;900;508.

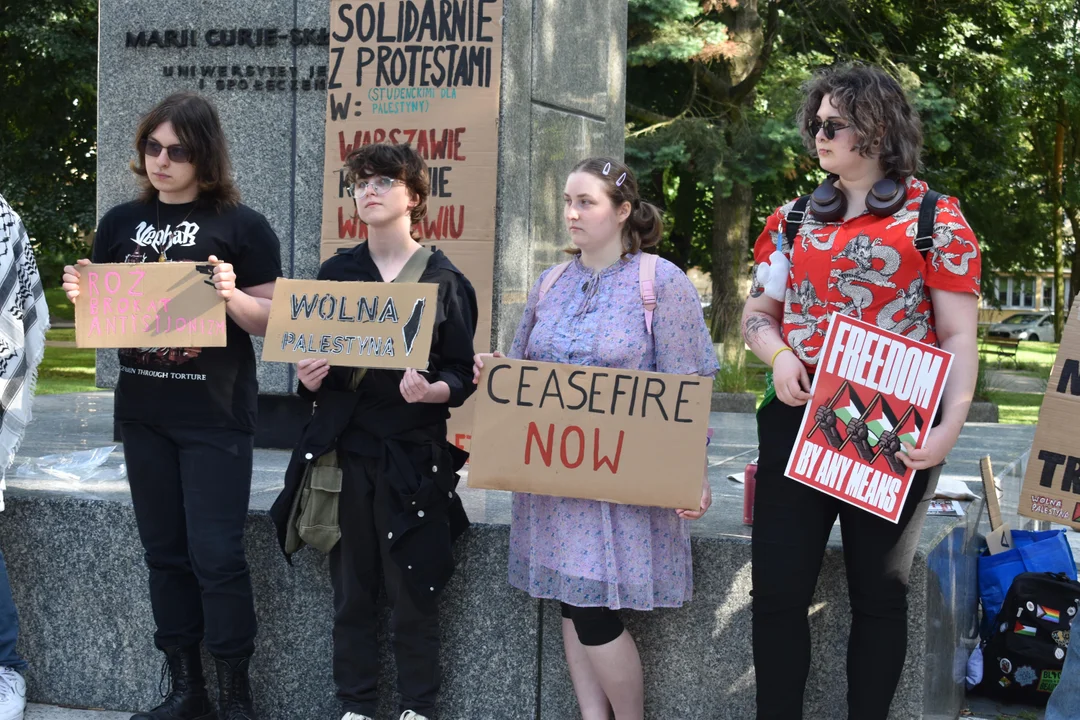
322;0;502;350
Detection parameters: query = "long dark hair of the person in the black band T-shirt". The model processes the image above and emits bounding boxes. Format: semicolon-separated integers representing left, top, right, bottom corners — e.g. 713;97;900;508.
131;92;240;213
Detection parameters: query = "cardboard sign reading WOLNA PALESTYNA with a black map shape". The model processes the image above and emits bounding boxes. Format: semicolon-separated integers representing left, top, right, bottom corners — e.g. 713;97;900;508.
262;277;438;370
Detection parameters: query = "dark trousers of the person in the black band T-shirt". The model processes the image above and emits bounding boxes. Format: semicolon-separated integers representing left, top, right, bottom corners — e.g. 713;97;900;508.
120;422;256;658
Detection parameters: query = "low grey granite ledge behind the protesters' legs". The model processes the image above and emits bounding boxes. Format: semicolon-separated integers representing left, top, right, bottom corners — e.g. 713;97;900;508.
0;393;1032;720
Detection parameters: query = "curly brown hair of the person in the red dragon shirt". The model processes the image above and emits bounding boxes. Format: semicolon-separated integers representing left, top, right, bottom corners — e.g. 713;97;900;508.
797;63;922;178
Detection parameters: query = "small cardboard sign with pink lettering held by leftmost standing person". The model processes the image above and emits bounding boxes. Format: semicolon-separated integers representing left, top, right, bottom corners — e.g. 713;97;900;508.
75;262;226;348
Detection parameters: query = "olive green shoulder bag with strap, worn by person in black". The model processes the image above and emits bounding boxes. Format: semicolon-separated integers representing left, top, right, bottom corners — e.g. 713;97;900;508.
285;247;431;555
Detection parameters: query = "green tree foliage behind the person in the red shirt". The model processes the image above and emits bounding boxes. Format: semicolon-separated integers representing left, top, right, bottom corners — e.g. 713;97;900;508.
626;0;1080;345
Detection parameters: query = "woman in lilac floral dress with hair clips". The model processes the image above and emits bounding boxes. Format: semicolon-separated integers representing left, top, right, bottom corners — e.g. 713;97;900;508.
474;158;718;720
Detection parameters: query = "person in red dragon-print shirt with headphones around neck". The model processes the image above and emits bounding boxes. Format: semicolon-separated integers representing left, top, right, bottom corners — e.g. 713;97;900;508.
742;65;981;720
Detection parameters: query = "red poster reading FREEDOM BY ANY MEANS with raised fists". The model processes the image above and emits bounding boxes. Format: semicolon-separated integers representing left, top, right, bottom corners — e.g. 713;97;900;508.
785;315;953;522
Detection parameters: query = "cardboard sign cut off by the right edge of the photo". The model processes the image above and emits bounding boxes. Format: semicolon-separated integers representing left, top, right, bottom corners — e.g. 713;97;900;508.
1020;296;1080;530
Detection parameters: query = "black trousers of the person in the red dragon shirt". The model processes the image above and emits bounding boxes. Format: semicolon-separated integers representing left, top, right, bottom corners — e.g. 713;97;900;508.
752;399;940;720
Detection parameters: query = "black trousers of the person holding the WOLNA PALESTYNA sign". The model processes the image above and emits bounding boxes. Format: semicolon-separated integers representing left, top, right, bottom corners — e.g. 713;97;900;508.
329;452;440;717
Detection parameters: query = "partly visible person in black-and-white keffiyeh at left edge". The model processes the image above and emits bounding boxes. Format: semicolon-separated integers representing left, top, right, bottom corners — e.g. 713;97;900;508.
0;195;49;720
